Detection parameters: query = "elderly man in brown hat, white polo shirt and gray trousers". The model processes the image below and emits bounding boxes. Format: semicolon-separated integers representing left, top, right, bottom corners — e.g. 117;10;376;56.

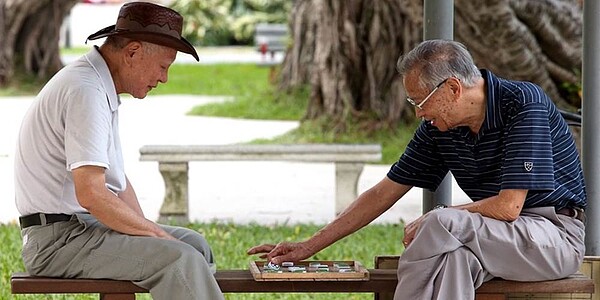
15;2;223;300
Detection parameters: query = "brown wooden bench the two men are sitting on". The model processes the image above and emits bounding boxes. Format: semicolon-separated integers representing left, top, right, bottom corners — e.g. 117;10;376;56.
11;269;594;300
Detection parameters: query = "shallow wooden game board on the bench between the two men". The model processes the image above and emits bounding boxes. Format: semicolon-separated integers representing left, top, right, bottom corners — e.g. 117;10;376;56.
250;260;369;281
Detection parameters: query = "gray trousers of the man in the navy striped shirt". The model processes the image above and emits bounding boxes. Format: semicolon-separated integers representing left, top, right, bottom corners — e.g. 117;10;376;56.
394;207;585;300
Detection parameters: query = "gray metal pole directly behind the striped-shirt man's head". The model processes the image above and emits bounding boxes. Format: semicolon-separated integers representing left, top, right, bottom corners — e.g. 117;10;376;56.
423;0;454;213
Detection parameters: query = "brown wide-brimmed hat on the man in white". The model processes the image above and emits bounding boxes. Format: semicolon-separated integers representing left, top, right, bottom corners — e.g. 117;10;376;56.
86;2;199;61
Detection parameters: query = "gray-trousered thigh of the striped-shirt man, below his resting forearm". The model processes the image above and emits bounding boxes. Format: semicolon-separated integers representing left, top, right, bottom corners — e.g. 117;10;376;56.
426;207;584;281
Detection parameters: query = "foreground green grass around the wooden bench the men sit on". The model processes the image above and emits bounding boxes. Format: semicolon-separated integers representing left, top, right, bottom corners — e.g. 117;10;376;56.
0;223;403;300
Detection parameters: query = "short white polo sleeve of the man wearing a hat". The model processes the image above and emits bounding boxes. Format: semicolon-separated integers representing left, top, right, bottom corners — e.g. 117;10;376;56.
64;89;112;171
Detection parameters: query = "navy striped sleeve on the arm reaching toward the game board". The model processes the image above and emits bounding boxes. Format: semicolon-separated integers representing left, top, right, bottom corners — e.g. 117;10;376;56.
387;122;448;191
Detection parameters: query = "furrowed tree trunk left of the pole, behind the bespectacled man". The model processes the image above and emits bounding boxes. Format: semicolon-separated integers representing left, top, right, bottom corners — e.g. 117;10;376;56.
280;0;421;125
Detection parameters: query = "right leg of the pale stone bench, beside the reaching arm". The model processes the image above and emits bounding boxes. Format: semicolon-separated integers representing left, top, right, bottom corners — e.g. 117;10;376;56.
335;162;364;215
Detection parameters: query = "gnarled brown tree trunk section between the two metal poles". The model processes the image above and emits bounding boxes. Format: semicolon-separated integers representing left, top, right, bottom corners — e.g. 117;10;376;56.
455;0;583;108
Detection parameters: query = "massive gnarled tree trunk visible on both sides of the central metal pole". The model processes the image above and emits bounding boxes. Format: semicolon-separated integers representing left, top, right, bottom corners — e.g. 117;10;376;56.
279;0;582;124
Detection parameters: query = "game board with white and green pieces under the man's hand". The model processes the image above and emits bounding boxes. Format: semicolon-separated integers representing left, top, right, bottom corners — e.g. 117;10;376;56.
250;261;369;281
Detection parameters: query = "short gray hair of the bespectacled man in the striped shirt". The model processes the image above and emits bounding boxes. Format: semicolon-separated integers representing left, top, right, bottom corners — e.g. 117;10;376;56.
396;40;481;89
